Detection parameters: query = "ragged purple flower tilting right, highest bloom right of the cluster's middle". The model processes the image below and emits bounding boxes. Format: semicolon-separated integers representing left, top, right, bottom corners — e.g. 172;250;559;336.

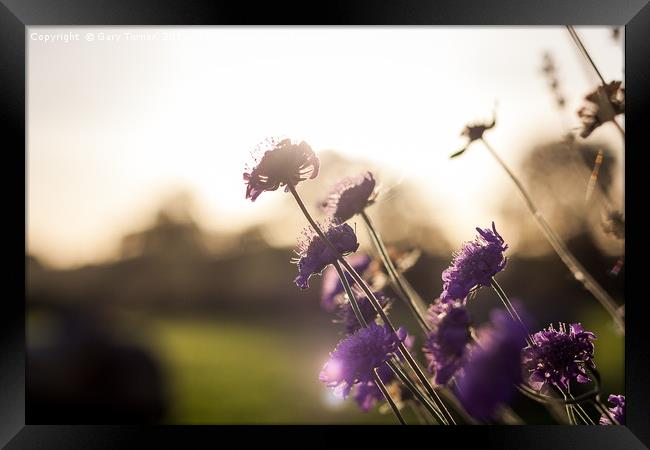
440;222;508;301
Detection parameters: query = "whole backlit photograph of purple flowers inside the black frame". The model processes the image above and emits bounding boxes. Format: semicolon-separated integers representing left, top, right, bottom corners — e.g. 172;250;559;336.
25;25;624;427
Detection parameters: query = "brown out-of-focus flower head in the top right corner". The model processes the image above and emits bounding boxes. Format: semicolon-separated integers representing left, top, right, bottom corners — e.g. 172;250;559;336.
578;81;625;138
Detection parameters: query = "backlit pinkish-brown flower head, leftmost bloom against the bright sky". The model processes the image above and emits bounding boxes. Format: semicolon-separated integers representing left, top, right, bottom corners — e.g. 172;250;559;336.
244;138;320;201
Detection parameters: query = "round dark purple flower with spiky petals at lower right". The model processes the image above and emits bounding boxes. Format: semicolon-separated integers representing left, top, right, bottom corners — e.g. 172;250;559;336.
522;323;596;391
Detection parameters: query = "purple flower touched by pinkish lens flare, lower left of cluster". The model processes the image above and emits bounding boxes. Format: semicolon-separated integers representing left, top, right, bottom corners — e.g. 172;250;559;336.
319;323;406;397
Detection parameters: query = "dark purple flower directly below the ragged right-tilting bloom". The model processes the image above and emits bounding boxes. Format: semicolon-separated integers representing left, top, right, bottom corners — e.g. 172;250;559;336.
423;300;471;384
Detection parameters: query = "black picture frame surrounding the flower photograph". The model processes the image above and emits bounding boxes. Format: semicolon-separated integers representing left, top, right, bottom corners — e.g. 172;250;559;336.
0;0;650;449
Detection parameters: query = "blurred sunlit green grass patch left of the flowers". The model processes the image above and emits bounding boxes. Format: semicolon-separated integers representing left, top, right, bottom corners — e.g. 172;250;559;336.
148;319;415;424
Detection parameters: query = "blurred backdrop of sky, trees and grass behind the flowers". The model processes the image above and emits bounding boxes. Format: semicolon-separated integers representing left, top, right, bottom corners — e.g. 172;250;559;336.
26;27;625;424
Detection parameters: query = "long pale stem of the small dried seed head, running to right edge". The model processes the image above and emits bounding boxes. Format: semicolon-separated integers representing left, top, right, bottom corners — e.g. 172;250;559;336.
481;138;625;334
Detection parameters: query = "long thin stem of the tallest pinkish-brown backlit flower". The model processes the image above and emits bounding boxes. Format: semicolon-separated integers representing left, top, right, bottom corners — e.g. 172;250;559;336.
287;184;455;424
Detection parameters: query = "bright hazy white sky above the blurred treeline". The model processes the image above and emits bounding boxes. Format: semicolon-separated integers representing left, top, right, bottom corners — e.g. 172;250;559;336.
26;27;623;266
